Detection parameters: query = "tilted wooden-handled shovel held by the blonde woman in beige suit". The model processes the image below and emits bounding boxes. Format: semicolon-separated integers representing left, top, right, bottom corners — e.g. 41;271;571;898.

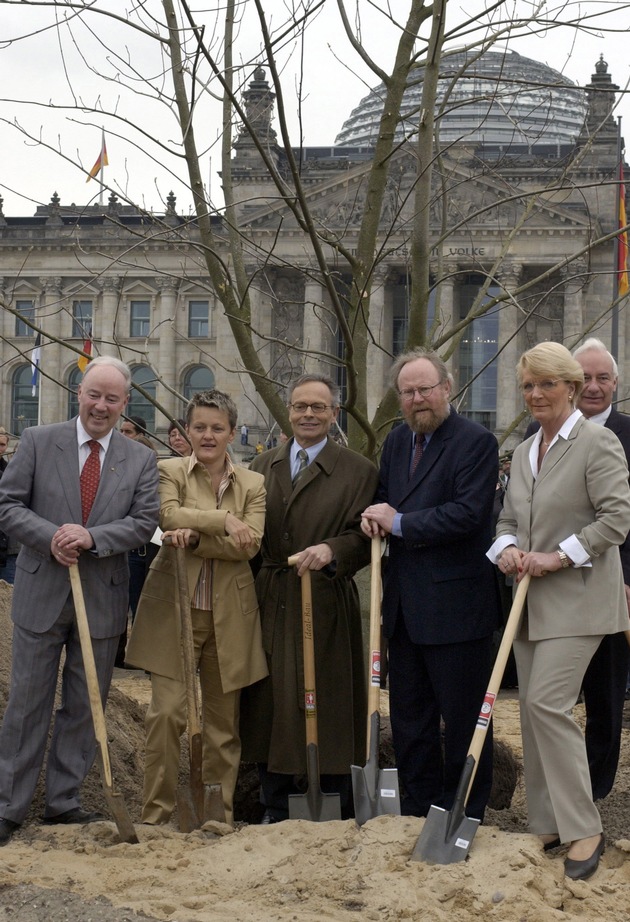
411;573;530;864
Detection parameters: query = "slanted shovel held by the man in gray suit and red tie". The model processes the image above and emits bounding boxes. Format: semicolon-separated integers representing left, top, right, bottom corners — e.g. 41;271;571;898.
69;563;138;843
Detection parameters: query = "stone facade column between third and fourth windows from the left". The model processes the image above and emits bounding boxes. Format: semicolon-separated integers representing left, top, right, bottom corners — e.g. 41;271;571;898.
155;276;179;416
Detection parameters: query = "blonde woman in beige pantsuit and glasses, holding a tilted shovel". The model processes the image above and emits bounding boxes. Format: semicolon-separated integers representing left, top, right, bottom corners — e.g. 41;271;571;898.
488;342;630;880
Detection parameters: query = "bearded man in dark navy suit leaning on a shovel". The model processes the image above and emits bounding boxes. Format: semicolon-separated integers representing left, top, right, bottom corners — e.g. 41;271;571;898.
362;348;499;820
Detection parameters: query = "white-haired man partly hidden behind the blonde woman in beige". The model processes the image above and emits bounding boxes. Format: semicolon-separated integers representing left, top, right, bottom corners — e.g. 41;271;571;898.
525;338;630;800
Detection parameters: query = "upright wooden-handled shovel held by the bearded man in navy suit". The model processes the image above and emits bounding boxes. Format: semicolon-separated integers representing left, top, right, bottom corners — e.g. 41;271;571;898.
351;536;400;826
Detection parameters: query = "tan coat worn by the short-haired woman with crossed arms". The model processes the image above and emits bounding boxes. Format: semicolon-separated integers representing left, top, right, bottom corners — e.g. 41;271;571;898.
126;458;267;692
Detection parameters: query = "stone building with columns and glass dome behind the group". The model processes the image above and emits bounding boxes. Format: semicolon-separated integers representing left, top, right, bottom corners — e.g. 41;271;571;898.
0;55;630;445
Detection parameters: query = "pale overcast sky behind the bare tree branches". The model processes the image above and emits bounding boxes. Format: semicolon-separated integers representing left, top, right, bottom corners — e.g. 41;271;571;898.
0;0;630;216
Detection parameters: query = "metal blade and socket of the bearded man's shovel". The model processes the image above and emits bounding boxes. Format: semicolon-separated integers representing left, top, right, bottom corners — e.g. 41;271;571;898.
350;711;400;826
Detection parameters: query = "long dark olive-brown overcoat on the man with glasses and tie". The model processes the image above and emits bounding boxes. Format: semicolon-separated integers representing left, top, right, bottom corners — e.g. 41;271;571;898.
241;440;378;774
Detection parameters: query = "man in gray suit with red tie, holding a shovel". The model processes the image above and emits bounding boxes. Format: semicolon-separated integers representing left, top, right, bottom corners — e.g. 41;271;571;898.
0;356;159;845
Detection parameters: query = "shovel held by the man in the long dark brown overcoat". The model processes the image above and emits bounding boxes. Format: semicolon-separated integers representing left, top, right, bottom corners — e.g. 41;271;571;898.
288;555;341;823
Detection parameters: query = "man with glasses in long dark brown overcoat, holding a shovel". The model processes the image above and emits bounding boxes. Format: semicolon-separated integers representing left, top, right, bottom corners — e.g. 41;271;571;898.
241;374;378;824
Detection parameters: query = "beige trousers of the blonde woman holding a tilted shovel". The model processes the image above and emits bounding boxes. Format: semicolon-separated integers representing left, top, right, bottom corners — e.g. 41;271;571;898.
514;631;602;842
